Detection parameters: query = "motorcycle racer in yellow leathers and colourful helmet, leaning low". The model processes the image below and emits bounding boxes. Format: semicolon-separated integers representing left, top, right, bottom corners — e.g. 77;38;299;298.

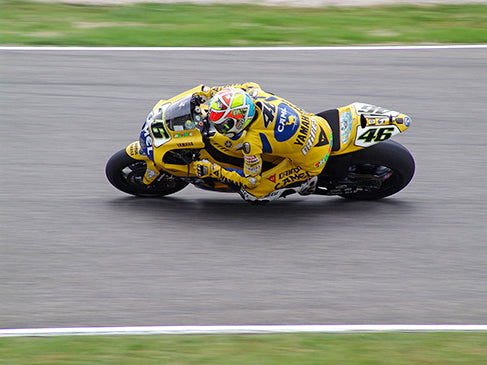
190;82;333;201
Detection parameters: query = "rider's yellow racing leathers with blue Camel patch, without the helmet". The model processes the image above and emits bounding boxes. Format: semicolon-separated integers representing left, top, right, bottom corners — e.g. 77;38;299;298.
193;83;332;200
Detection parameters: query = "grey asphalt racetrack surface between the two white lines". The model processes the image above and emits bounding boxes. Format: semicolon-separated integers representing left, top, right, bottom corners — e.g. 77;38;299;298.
0;49;487;328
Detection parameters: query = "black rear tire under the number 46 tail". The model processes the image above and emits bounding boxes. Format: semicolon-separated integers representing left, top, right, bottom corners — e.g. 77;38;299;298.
340;140;415;200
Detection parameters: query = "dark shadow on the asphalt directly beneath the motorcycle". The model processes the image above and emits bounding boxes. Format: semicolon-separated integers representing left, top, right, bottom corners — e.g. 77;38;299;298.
107;193;415;223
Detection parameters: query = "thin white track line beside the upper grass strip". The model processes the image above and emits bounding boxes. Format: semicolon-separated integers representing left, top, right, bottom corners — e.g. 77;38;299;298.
0;44;487;52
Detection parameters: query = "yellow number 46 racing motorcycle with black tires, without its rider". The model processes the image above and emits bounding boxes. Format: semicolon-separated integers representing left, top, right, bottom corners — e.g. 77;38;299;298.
105;87;415;202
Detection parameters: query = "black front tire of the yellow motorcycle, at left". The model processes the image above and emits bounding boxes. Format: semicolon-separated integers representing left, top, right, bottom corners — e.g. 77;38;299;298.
105;149;188;197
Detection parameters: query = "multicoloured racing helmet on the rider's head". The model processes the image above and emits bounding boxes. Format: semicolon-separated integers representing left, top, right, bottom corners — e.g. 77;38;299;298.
208;87;255;137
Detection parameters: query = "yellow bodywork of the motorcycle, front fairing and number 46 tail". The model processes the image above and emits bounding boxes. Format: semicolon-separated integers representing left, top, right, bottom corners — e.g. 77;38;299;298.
127;85;411;192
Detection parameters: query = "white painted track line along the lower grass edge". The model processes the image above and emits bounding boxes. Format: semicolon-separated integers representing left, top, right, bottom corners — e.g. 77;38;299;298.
0;324;487;337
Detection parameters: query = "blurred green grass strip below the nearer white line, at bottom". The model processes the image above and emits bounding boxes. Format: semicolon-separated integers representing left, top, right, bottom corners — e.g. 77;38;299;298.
0;333;487;365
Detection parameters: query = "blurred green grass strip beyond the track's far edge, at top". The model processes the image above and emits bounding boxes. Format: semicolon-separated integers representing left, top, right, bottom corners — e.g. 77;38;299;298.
0;0;487;47
